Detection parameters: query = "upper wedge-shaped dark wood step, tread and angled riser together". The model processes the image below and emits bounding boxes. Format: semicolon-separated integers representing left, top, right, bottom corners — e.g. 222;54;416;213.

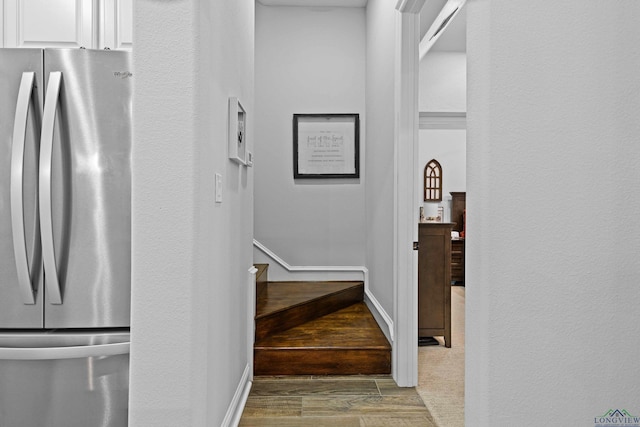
256;281;364;341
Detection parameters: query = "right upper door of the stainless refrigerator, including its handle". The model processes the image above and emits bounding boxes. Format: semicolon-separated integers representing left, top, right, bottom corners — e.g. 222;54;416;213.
39;49;132;328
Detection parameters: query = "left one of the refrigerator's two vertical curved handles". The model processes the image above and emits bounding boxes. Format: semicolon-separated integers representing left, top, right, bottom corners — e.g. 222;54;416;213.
11;72;36;304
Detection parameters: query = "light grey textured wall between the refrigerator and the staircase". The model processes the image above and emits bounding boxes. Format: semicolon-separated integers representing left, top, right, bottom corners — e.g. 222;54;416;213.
130;0;254;427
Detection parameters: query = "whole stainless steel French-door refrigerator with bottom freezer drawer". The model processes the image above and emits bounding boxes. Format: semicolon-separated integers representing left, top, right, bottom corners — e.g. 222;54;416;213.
0;49;132;427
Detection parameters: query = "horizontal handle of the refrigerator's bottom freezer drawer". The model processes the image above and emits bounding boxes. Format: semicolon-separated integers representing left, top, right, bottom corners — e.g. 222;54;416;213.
0;341;131;360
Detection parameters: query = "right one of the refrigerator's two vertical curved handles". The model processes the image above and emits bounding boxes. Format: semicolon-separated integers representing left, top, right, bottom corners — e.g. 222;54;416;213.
38;71;62;304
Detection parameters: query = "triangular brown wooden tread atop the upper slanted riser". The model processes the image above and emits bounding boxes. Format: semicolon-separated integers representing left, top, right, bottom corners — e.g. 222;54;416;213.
256;281;364;320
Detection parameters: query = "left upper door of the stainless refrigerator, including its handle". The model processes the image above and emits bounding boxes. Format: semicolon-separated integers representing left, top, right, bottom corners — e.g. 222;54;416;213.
0;49;44;328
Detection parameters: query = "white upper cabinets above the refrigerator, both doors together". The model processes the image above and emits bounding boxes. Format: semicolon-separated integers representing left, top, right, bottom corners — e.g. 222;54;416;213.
0;0;133;50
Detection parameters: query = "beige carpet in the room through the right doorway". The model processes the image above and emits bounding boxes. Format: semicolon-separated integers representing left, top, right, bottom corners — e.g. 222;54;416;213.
417;286;465;427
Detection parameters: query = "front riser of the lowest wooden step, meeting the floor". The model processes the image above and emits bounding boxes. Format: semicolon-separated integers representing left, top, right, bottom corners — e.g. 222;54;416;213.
254;349;391;375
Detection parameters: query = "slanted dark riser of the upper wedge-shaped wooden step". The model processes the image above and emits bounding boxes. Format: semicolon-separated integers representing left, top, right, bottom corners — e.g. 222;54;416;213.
256;286;364;342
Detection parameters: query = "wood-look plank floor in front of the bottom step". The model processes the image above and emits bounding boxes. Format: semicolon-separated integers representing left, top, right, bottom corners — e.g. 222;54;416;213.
240;376;435;427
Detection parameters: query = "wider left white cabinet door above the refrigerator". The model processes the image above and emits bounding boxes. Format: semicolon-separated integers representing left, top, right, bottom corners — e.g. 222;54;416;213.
2;0;97;48
